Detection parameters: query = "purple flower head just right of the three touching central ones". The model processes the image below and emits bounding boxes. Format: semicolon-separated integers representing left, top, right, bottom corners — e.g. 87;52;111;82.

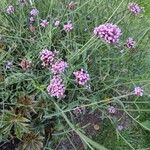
73;69;90;85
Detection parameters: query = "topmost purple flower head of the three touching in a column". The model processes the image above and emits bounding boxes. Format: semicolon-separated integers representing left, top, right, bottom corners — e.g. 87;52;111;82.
40;49;56;66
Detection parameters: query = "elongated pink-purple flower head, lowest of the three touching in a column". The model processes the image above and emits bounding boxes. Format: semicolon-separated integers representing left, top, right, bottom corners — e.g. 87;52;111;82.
47;75;65;98
